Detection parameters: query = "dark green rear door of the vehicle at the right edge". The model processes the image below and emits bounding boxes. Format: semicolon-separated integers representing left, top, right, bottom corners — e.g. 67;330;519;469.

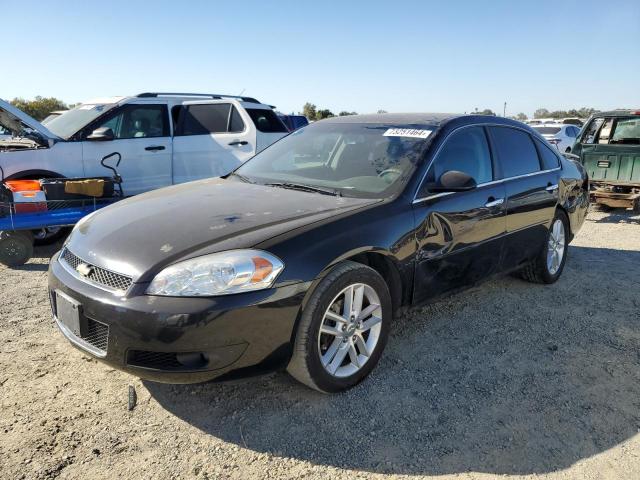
581;116;640;185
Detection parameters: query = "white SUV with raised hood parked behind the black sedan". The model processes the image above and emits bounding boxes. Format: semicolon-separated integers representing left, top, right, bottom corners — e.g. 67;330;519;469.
0;93;288;195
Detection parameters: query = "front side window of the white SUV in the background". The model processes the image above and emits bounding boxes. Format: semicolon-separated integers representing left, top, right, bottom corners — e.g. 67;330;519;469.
96;105;169;140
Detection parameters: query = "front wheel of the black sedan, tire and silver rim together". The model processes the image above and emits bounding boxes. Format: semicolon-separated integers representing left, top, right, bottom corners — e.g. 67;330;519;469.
287;261;392;393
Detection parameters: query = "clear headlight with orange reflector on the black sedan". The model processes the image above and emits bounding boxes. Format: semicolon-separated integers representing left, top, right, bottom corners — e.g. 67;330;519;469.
147;250;284;297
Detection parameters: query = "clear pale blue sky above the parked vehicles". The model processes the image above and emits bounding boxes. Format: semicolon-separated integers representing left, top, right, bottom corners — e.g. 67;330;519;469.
0;0;640;116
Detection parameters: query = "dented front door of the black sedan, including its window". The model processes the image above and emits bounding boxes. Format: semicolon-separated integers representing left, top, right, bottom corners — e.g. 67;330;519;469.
414;126;506;303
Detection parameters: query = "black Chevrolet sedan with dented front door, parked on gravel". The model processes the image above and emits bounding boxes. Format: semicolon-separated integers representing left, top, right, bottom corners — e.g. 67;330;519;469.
49;114;588;392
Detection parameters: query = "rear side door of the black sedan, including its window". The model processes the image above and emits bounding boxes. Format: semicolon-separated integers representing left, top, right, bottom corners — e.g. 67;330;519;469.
489;126;560;269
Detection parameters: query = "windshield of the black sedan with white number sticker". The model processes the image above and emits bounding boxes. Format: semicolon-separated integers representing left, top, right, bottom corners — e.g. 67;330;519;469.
236;122;435;198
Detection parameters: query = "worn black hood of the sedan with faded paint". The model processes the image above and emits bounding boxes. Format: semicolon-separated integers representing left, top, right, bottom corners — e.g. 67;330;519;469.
67;178;379;281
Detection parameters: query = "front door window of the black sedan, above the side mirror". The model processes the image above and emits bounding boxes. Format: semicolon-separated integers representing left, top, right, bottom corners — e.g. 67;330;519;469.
419;127;493;195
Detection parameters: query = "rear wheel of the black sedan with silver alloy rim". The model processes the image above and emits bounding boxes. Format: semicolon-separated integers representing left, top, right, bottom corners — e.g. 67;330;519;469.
520;210;569;283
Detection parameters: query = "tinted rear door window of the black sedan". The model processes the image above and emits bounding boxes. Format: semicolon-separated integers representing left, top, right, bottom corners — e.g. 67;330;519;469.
490;127;540;178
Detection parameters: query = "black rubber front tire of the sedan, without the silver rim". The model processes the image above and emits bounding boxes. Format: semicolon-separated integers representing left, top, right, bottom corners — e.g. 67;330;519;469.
287;261;392;393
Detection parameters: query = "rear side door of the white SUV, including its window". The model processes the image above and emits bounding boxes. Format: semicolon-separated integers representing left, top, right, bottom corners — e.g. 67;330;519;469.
172;101;256;183
